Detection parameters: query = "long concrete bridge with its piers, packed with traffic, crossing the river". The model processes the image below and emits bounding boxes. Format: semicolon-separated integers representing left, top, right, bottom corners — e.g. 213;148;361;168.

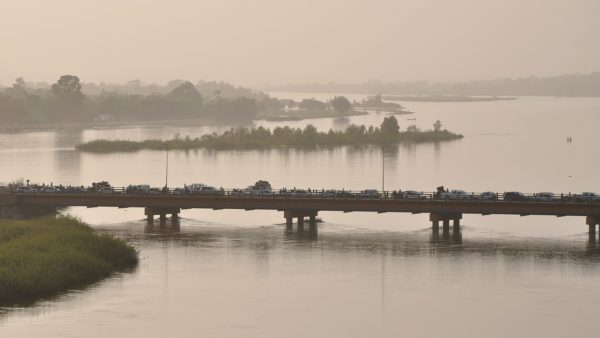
0;189;600;239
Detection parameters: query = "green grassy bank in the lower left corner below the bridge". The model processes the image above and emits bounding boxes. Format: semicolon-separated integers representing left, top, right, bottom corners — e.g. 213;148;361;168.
0;216;138;304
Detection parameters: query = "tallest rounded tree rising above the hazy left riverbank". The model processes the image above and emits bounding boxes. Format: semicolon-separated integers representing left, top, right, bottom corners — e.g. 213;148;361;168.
51;75;84;120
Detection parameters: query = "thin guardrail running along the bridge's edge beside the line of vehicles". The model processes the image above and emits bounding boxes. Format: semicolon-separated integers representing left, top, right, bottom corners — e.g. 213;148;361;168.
5;186;600;203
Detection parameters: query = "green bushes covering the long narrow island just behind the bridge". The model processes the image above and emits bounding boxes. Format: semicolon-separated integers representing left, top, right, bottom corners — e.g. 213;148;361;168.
76;116;463;153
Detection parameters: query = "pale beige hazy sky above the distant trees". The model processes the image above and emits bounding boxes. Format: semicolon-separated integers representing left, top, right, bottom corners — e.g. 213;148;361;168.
0;0;600;85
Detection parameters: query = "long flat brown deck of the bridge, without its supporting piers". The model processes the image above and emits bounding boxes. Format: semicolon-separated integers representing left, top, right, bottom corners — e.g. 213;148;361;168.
11;193;600;216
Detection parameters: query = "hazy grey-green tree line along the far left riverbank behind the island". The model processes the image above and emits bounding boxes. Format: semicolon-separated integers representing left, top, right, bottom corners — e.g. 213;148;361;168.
0;75;360;125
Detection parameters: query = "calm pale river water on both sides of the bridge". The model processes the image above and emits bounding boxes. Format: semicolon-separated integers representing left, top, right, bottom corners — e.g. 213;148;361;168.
0;93;600;338
